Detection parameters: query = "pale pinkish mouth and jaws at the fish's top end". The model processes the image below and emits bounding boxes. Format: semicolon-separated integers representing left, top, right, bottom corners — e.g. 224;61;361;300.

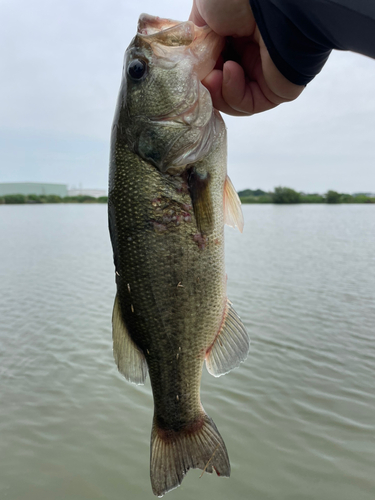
137;14;225;81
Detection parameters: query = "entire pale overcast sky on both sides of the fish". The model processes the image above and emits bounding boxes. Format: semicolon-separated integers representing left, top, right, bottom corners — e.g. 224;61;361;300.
0;0;375;193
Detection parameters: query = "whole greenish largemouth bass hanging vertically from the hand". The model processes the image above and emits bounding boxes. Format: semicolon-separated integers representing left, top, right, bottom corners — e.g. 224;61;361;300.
108;14;249;497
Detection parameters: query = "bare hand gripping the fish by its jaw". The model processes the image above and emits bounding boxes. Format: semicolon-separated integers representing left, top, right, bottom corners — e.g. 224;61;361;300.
190;0;305;116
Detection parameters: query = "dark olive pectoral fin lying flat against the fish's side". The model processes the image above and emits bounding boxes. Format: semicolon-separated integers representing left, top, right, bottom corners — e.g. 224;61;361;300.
188;168;214;235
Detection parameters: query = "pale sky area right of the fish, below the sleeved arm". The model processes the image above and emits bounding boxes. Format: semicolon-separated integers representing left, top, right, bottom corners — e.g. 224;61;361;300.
226;52;375;192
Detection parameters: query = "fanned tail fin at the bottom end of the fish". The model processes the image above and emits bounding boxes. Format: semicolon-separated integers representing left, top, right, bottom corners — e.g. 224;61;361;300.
150;414;230;497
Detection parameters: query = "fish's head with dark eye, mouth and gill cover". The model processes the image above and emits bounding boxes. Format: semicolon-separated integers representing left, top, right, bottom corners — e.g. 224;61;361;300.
117;14;224;172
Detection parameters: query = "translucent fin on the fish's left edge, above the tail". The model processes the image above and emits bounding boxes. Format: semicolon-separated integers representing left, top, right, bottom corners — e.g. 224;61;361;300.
112;295;147;385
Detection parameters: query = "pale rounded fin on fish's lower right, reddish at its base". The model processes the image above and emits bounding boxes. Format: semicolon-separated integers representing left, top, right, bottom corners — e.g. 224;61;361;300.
206;300;250;377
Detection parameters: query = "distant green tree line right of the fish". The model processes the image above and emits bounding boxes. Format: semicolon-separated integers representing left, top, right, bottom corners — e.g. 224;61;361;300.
238;186;375;204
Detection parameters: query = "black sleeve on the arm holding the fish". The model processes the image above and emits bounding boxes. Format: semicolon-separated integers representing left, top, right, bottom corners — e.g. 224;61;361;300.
250;0;375;85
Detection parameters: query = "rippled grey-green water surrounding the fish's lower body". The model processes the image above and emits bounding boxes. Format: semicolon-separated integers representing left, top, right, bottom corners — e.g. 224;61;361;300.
0;205;375;500
